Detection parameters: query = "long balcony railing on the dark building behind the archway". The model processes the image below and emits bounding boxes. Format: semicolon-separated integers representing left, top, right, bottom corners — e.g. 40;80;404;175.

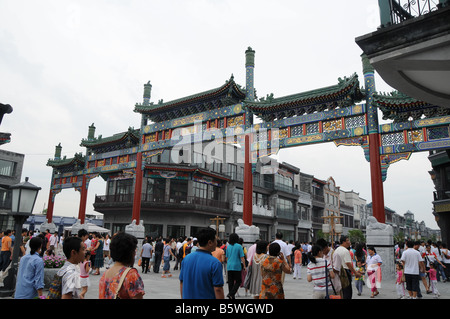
95;194;230;209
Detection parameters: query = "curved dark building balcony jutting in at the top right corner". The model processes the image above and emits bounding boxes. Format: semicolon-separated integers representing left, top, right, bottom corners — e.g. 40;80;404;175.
355;0;450;108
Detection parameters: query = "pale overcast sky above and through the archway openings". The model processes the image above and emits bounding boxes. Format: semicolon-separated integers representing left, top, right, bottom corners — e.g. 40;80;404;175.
0;0;437;229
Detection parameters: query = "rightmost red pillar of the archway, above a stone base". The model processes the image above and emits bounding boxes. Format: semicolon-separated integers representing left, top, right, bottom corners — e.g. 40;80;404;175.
369;133;386;224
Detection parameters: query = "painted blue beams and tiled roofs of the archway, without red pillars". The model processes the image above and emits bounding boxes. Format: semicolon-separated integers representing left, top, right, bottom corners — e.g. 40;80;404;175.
47;64;450;194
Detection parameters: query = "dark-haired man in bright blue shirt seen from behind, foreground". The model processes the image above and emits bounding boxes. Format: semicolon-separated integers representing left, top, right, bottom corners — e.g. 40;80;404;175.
179;227;224;299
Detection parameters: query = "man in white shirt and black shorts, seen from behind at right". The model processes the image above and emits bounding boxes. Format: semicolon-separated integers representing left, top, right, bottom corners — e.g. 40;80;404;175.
400;240;425;299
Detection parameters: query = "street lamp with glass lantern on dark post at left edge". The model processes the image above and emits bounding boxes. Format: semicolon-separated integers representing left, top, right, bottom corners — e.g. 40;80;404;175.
0;177;41;297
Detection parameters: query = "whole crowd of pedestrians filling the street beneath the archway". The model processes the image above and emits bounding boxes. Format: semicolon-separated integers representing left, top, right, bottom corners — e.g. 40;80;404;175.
0;228;450;299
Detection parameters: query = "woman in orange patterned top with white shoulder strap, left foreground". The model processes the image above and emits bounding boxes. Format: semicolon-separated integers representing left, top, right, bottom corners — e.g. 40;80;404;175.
99;233;145;299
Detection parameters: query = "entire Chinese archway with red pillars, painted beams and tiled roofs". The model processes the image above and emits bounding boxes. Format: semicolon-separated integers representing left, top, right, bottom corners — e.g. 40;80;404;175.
47;48;450;232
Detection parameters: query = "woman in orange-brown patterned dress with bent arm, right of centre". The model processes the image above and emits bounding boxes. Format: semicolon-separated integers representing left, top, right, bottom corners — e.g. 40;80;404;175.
259;243;291;299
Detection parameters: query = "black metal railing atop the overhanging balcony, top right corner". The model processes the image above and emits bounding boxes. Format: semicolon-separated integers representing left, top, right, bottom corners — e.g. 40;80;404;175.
378;0;449;26
